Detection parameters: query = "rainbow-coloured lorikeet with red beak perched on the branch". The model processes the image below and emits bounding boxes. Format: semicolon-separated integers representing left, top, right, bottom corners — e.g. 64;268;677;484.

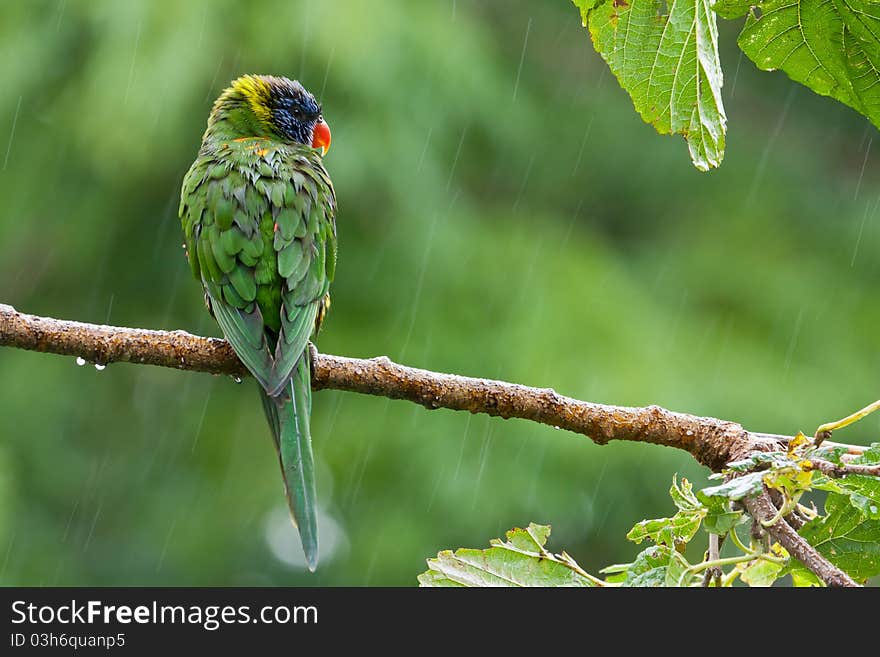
180;75;336;570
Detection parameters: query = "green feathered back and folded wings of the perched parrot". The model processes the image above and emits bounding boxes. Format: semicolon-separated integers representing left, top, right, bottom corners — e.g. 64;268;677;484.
180;138;336;395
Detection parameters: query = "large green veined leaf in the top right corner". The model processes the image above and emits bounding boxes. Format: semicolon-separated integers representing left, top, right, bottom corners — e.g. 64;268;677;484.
714;0;880;131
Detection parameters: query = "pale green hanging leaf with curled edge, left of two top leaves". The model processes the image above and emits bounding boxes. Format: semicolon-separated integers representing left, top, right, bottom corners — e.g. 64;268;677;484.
573;0;727;171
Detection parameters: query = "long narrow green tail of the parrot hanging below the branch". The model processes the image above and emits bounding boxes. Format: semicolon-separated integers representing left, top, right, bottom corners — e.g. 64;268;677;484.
260;354;318;571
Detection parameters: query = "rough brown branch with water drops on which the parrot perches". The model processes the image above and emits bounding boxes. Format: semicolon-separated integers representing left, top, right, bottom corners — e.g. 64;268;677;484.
0;304;857;586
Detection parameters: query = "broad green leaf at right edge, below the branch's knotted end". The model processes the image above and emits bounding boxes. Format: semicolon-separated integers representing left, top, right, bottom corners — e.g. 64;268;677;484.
800;493;880;580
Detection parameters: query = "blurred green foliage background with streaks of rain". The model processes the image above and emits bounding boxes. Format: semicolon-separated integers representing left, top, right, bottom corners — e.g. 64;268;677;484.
0;0;880;585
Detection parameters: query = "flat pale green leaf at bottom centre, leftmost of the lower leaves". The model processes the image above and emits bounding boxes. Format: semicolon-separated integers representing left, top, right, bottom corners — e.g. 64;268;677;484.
418;523;603;586
